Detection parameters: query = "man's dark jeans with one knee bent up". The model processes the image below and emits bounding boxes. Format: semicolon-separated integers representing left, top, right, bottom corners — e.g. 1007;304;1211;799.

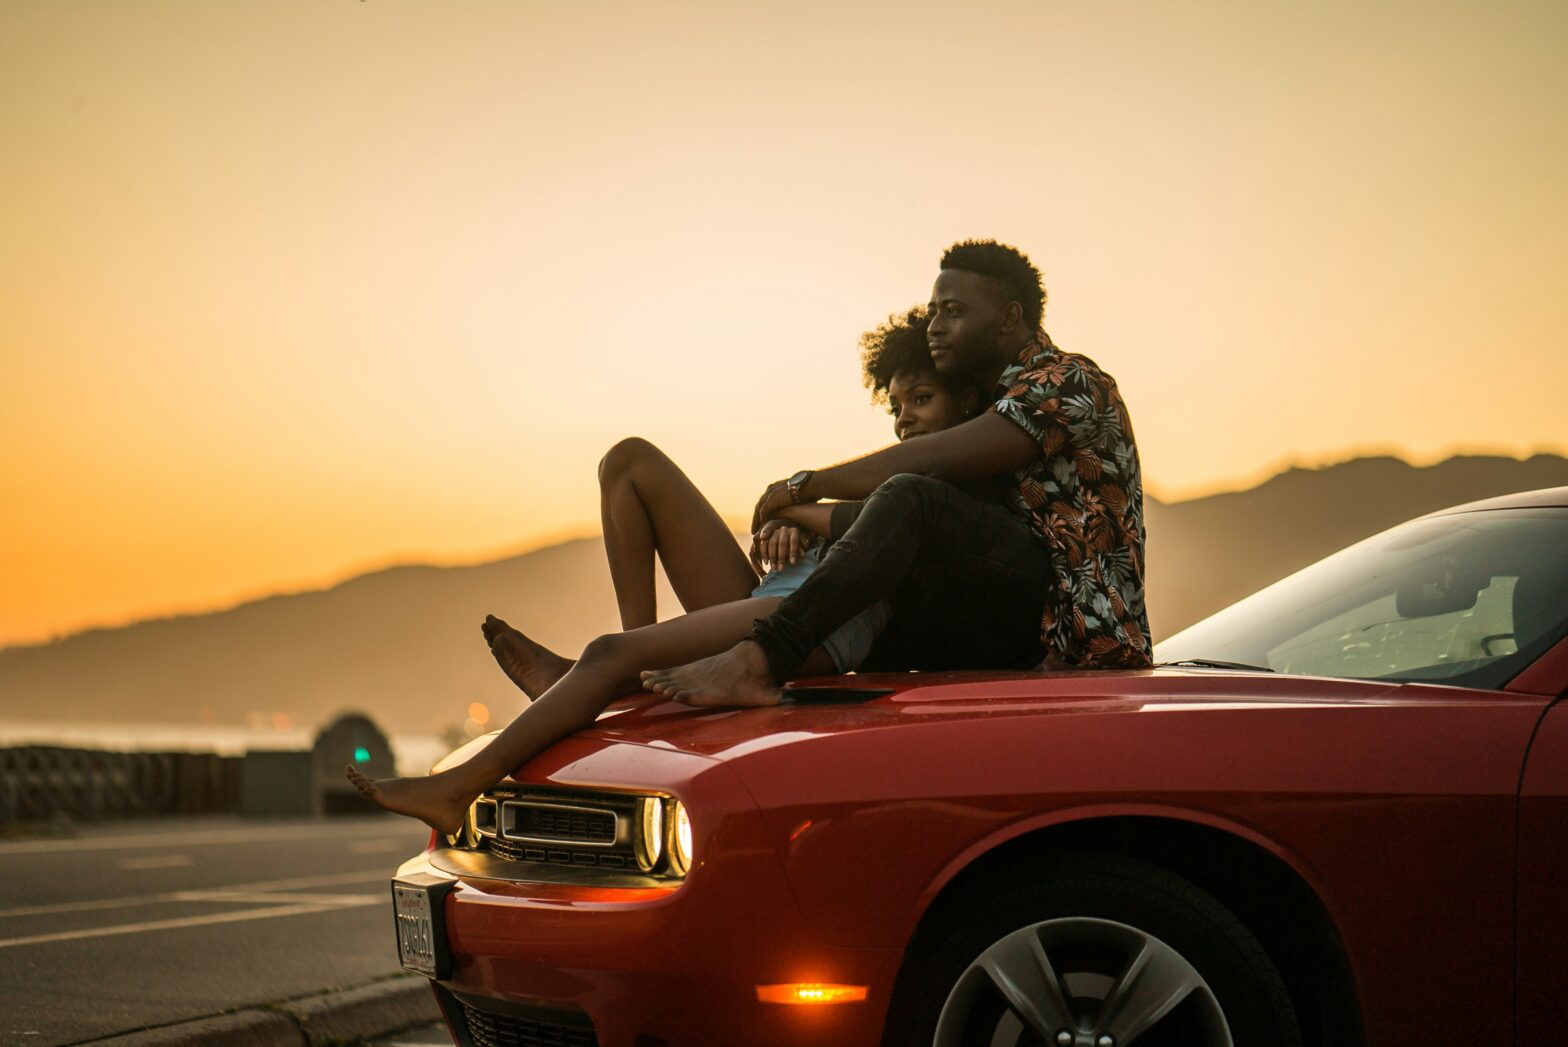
751;473;1054;683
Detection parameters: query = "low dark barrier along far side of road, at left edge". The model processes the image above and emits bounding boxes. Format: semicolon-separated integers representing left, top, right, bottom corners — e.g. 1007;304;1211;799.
0;746;240;823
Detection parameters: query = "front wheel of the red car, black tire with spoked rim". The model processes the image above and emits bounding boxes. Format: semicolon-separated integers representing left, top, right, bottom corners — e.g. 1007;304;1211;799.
883;853;1301;1047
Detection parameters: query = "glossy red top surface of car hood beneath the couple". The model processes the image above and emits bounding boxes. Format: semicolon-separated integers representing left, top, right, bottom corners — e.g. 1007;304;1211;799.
579;668;1397;759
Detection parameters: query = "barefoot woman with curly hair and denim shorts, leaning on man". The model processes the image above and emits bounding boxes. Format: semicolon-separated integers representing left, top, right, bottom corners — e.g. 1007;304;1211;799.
347;309;980;832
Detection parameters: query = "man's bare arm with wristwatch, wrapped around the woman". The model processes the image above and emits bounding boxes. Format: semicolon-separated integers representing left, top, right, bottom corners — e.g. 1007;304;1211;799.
753;412;1040;530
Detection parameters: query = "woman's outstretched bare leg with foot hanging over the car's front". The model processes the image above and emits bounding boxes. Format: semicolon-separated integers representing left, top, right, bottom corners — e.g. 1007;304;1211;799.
348;597;833;832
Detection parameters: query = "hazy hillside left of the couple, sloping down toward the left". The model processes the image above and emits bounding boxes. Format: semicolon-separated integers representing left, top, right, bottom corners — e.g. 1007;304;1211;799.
0;539;679;732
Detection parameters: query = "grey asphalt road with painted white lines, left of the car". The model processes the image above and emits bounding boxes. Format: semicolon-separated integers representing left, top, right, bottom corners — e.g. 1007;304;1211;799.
0;815;428;1047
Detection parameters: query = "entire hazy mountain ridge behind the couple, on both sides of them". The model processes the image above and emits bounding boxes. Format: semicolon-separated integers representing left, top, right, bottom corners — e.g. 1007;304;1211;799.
0;455;1568;732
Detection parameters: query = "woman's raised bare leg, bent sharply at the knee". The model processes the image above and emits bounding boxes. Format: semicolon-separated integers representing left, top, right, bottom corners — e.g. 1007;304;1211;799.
599;437;757;630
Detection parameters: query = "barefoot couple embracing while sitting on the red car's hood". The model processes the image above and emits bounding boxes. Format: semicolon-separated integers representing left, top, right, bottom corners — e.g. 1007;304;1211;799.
348;240;1149;832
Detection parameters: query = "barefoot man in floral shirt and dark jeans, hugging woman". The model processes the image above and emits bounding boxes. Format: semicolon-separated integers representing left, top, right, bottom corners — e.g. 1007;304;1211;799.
643;240;1149;705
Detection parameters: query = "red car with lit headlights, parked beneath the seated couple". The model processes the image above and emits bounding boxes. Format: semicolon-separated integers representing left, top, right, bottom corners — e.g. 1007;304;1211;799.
394;487;1568;1047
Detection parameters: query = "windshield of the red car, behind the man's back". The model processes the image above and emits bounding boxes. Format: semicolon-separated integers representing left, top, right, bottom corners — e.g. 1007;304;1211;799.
1154;509;1568;688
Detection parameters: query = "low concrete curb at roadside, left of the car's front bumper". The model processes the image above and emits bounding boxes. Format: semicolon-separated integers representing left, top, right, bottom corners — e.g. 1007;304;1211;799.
91;976;441;1047
